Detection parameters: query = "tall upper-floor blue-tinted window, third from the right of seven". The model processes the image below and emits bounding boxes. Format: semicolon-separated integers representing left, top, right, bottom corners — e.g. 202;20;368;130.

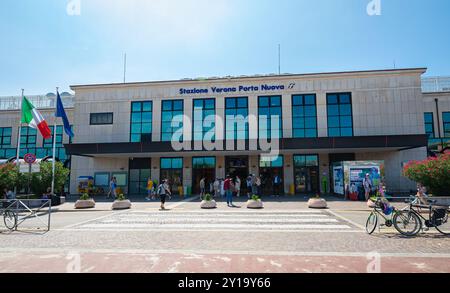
258;96;283;139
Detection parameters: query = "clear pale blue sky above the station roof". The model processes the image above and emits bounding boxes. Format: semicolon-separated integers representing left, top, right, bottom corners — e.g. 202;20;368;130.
0;0;450;96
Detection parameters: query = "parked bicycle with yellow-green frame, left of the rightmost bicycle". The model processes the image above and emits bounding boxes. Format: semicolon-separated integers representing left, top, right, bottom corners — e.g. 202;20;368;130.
366;198;420;236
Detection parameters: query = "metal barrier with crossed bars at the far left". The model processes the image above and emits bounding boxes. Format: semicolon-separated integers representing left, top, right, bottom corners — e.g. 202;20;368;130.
0;199;52;232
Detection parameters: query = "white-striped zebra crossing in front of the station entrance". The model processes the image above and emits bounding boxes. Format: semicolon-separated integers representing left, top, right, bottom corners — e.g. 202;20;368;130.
67;210;357;232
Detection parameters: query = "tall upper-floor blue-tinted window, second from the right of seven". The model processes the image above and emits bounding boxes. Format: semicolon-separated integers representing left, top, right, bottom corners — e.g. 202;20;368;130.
292;95;317;138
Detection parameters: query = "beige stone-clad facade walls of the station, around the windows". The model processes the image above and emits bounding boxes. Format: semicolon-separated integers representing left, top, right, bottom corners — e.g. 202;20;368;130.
0;68;450;194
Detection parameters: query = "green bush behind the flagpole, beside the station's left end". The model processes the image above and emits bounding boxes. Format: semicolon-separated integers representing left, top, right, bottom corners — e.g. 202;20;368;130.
31;162;70;195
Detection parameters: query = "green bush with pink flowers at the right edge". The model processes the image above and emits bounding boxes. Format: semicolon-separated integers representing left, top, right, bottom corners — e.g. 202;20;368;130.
403;151;450;196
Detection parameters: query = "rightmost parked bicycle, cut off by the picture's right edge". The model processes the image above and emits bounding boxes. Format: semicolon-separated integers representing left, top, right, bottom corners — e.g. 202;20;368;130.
394;196;450;237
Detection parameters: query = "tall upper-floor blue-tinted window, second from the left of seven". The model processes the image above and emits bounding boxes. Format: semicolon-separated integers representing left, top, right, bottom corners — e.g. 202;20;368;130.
161;100;184;141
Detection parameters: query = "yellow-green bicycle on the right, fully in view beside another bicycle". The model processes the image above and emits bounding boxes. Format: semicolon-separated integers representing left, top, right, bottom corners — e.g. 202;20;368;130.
366;198;420;235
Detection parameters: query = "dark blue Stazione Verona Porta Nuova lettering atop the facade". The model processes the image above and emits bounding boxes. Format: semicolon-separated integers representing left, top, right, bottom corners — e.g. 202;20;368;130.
179;83;295;95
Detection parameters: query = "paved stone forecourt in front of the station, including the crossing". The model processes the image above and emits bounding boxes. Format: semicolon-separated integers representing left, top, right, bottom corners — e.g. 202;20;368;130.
0;197;450;272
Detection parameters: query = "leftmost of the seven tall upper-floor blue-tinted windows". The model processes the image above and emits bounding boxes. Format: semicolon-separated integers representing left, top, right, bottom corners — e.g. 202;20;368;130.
130;102;153;142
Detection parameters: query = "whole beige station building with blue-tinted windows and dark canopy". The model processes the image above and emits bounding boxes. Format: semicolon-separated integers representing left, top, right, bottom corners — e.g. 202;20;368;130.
0;68;450;195
